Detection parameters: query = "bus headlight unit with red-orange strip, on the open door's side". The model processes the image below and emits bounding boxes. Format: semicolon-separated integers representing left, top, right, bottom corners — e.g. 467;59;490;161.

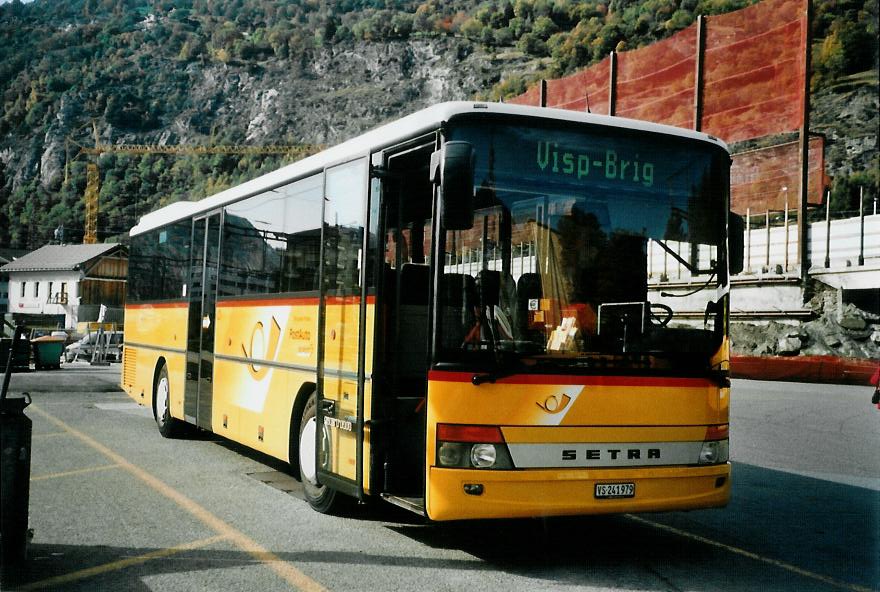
437;424;513;469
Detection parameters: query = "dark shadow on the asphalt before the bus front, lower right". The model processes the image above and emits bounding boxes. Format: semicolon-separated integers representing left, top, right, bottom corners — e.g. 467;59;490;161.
389;463;880;590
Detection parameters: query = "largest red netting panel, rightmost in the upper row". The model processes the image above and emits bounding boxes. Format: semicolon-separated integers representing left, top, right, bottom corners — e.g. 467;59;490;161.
703;0;806;143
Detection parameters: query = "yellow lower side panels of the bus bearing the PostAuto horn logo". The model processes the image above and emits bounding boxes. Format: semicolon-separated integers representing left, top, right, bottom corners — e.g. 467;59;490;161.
122;297;374;492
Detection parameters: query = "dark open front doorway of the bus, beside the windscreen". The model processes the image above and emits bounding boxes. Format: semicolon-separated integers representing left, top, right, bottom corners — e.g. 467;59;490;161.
372;139;437;513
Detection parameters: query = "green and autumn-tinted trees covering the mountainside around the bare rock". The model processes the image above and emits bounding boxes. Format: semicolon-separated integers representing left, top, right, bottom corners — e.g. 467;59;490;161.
0;0;878;246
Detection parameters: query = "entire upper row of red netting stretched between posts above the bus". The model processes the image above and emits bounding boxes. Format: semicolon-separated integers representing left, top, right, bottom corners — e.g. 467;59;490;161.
510;0;807;143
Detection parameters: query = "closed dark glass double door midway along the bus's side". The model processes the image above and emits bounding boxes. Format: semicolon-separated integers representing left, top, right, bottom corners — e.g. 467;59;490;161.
183;212;220;430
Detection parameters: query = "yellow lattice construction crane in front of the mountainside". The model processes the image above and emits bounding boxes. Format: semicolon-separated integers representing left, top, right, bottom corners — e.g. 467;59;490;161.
65;121;322;244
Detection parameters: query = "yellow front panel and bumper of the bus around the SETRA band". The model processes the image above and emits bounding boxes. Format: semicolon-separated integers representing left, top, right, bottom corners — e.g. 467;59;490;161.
426;372;730;520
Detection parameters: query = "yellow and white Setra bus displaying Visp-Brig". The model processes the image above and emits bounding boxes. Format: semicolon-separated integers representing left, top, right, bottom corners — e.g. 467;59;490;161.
122;102;742;521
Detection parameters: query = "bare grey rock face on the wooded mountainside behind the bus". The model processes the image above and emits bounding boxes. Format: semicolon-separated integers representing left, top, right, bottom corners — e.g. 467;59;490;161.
0;37;537;193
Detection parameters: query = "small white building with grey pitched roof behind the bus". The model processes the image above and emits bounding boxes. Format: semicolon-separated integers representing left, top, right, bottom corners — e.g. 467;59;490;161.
0;244;128;331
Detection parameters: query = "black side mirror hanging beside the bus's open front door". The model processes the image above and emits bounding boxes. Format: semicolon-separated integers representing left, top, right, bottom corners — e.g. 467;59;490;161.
431;142;474;230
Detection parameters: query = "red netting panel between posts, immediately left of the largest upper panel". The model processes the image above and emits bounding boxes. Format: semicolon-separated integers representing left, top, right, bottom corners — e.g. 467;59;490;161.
615;26;697;128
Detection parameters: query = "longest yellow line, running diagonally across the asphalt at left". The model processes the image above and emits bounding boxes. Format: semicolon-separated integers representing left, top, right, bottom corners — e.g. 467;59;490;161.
30;404;326;592
